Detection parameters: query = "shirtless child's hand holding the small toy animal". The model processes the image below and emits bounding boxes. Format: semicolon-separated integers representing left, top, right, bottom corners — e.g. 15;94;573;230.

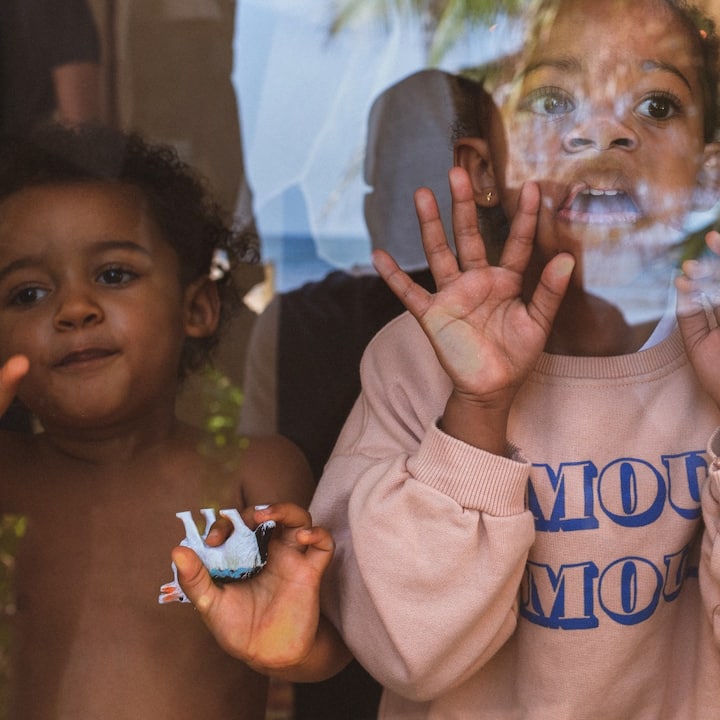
172;503;345;679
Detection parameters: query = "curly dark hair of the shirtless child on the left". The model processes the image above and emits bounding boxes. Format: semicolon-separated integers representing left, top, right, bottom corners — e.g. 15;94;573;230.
0;125;258;378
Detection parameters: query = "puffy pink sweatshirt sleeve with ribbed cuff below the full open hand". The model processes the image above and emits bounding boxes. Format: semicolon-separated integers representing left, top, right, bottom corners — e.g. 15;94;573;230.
311;316;534;701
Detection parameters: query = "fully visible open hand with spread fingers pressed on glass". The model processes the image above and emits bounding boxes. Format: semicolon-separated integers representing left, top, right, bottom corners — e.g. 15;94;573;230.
374;167;574;406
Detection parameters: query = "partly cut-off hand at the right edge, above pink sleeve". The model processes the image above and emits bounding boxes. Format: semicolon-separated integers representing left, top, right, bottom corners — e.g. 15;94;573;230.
676;231;720;407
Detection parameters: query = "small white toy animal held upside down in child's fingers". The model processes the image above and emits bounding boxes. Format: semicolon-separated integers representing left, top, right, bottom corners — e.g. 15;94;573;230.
158;508;275;605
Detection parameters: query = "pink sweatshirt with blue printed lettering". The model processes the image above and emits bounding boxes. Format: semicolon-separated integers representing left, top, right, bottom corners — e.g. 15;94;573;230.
311;315;720;720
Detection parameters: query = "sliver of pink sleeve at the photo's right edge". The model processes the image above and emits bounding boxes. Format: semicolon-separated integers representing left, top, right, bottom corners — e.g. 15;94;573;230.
700;428;720;646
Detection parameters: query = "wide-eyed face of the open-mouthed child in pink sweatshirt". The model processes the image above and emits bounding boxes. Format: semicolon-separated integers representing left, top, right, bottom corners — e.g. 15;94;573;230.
491;0;716;286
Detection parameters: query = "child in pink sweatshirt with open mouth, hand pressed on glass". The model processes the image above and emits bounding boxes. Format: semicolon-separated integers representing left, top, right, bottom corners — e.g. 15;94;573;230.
177;0;720;720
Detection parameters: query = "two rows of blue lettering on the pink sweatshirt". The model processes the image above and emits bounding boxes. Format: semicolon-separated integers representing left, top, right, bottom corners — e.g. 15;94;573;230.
520;451;708;630
